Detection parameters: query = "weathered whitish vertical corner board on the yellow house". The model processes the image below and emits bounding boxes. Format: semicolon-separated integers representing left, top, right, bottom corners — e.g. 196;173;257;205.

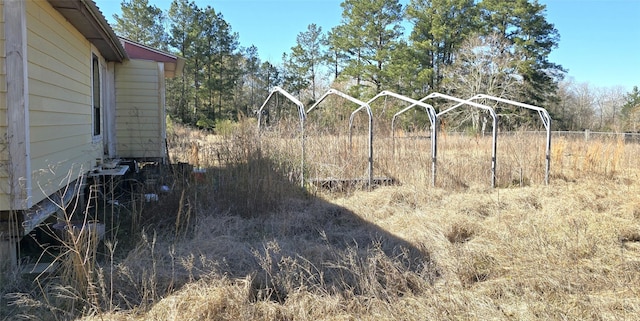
3;0;32;210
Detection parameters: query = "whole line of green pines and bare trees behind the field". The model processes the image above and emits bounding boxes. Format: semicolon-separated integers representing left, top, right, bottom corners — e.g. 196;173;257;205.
114;0;640;131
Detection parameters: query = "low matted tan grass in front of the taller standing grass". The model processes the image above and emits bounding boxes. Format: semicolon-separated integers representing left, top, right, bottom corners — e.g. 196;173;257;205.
79;179;640;320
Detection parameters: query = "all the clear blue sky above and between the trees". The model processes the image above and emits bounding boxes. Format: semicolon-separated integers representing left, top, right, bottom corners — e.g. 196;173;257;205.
95;0;640;91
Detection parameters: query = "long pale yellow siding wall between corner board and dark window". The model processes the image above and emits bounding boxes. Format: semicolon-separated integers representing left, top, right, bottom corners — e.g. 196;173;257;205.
26;1;102;204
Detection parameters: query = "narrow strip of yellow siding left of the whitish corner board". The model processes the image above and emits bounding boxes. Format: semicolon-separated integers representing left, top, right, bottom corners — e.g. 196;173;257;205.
0;1;10;206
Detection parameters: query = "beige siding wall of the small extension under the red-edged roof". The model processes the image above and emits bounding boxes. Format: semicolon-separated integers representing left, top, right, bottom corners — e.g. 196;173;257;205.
115;59;165;158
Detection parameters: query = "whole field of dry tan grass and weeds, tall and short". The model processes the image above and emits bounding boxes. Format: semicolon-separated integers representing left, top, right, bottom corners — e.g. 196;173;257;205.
3;121;640;320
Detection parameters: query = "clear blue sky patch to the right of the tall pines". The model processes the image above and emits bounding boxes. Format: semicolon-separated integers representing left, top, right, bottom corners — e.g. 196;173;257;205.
540;0;640;91
